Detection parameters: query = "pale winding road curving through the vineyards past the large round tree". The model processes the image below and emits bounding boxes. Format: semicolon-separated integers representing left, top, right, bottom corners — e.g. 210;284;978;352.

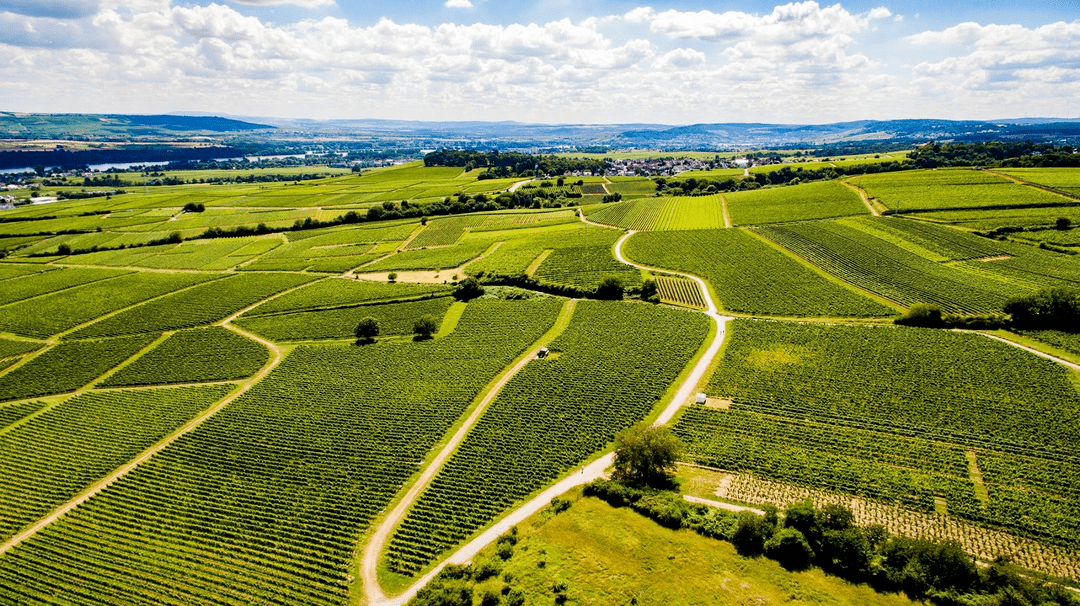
371;227;732;606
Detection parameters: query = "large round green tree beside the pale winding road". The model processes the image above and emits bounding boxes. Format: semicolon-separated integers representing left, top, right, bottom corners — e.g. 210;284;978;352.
613;423;683;486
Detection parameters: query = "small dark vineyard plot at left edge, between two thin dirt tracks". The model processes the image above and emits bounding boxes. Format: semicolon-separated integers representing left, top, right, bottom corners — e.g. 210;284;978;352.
0;336;154;400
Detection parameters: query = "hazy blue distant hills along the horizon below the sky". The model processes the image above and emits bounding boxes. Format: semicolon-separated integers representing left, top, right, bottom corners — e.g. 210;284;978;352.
0;112;1080;150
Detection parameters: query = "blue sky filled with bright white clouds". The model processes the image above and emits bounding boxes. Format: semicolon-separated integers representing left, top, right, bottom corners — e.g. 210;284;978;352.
0;0;1080;124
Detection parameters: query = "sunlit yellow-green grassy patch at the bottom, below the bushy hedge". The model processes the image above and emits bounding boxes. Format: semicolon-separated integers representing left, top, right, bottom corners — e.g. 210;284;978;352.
416;496;914;606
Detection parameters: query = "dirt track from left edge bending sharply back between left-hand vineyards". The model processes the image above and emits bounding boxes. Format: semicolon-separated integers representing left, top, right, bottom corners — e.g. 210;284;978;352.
0;293;284;555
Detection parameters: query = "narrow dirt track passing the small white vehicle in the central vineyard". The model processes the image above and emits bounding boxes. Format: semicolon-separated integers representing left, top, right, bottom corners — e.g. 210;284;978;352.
360;299;577;605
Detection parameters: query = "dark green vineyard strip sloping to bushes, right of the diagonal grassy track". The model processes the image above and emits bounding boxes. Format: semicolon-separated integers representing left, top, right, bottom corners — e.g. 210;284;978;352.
757;221;1031;313
